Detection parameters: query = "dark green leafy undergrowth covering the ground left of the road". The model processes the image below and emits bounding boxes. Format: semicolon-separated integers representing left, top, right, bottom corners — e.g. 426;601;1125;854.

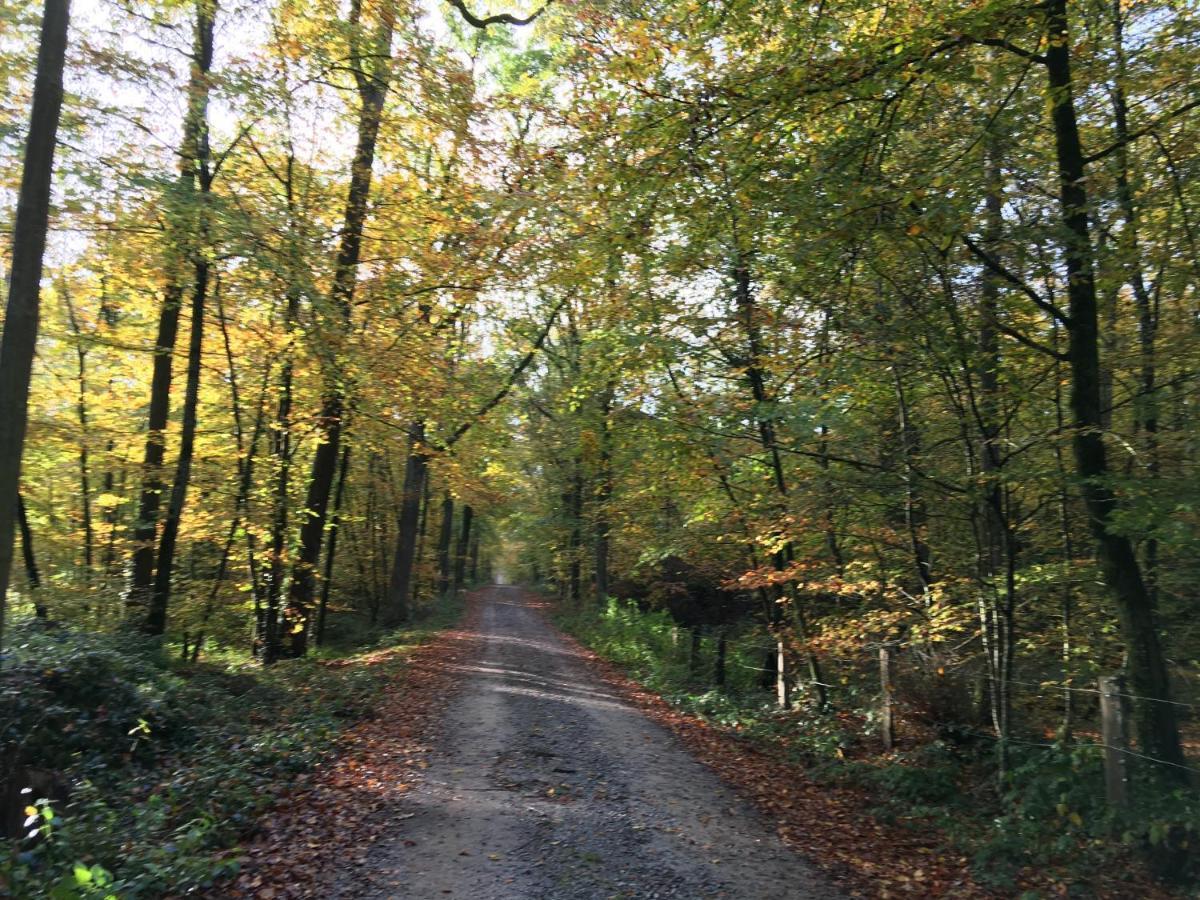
0;601;462;900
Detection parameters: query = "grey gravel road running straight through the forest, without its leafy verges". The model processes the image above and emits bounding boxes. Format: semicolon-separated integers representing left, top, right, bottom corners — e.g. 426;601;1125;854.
326;587;842;900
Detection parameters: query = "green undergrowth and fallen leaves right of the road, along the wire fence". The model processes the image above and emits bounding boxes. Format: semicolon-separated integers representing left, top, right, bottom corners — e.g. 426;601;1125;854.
556;600;1200;900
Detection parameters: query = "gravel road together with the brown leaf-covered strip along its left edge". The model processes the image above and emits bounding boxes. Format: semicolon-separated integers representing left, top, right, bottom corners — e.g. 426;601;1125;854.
222;587;848;900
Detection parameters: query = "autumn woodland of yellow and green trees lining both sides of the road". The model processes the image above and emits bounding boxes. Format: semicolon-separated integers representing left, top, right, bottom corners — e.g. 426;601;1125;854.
0;0;1200;897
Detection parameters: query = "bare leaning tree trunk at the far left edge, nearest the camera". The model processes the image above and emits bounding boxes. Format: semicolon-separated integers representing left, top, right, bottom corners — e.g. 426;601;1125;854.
0;0;70;648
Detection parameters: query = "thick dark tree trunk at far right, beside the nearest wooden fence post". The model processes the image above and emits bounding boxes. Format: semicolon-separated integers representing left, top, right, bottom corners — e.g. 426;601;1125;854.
1044;0;1186;778
